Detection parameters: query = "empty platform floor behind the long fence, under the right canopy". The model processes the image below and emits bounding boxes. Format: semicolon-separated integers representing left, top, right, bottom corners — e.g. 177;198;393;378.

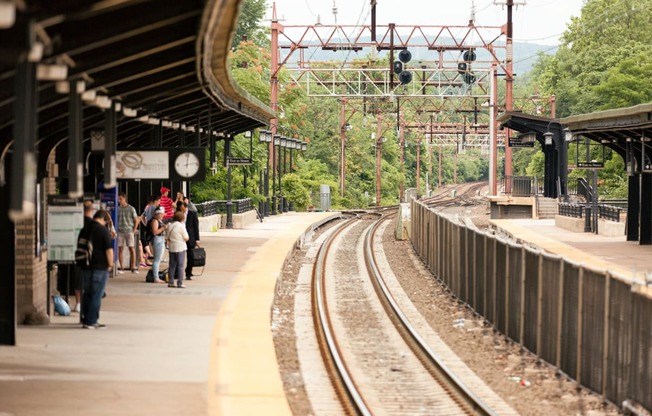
490;219;652;283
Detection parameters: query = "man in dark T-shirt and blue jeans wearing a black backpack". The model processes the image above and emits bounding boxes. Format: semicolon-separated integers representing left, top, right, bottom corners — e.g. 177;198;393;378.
75;210;113;329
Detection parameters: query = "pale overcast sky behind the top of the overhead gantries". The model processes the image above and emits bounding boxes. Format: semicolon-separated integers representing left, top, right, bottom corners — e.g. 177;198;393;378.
267;0;584;45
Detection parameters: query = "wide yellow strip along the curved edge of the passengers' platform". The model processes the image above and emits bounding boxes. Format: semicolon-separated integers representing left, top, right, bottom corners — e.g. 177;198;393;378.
207;213;333;416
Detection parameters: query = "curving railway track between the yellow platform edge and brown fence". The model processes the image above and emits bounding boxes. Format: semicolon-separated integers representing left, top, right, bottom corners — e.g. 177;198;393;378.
312;208;498;415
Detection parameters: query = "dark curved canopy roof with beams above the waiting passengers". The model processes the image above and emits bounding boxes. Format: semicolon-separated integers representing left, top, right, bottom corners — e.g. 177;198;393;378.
0;0;272;158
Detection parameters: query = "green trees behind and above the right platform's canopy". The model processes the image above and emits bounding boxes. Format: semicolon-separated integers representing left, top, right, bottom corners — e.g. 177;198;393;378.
513;0;652;198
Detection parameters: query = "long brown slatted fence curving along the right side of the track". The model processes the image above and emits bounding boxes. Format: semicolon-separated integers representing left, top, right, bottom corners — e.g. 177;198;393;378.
411;200;652;411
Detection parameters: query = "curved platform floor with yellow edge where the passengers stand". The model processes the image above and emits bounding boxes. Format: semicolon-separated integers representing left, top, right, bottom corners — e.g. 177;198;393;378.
0;213;333;416
